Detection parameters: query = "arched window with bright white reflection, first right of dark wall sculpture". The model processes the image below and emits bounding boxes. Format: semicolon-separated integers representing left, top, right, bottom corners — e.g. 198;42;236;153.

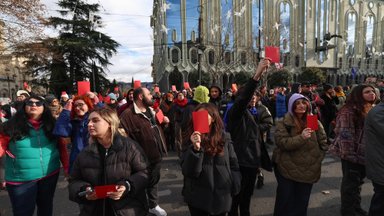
345;12;357;58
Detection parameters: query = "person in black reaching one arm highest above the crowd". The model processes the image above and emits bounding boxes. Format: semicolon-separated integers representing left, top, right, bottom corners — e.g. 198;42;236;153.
227;60;270;216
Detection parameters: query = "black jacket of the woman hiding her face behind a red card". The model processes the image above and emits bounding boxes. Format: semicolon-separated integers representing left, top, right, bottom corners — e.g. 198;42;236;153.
182;133;241;215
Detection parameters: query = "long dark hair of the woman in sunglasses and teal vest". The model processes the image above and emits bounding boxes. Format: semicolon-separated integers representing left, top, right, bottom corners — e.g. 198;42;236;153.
0;95;56;141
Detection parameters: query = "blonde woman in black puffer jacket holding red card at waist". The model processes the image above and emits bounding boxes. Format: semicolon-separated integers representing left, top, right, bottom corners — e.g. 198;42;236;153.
68;108;148;216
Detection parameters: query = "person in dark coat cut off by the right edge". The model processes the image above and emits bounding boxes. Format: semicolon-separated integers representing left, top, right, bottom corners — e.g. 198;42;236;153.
364;98;384;216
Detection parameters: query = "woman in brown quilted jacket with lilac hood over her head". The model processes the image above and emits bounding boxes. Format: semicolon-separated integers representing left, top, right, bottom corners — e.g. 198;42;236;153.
272;94;328;216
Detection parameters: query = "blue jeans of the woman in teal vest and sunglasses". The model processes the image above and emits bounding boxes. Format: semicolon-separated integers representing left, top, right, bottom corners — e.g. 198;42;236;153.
7;173;59;216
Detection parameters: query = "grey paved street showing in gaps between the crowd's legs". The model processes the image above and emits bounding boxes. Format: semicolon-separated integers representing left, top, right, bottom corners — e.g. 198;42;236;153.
0;148;373;216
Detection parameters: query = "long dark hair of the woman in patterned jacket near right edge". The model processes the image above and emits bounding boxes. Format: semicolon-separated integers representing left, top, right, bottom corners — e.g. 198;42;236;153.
341;84;377;123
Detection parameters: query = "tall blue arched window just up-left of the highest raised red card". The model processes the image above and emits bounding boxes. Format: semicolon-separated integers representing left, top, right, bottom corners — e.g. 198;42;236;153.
252;0;264;52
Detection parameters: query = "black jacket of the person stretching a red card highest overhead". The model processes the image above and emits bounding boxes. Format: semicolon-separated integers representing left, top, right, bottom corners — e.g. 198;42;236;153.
227;79;261;168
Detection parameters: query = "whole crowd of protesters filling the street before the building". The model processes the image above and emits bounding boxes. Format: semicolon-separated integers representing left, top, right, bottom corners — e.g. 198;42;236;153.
0;59;384;216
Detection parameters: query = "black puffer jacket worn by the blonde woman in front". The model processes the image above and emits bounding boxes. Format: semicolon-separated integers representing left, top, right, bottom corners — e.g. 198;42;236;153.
68;135;148;216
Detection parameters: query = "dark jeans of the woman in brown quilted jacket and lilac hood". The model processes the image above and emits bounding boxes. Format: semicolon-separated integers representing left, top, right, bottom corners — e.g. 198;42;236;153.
273;167;313;216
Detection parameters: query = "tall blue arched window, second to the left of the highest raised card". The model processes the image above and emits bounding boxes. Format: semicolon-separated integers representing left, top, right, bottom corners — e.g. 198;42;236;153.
221;0;233;50
